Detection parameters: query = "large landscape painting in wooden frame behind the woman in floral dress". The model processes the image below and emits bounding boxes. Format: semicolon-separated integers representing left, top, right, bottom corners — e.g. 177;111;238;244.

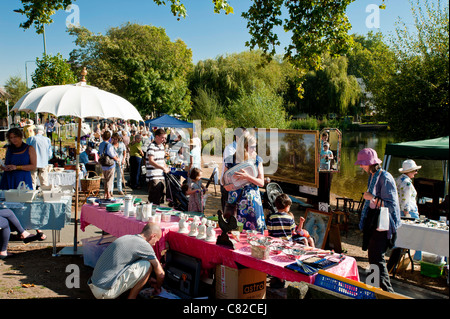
256;129;319;188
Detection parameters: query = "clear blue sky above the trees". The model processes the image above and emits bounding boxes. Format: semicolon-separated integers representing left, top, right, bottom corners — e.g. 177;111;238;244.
0;0;442;86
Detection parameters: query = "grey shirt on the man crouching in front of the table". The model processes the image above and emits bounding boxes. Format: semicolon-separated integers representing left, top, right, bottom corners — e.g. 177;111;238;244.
91;235;156;290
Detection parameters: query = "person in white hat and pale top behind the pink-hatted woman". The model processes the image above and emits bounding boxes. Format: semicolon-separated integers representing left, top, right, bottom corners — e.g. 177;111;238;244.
395;159;422;218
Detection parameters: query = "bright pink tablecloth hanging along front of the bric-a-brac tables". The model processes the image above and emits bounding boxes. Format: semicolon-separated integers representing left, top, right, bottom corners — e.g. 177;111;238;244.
80;205;359;283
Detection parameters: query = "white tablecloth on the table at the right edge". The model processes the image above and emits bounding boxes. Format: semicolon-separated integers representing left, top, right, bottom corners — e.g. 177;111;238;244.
395;223;449;257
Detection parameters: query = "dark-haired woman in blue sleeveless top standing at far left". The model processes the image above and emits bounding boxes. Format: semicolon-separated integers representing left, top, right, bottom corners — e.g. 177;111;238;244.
0;128;37;190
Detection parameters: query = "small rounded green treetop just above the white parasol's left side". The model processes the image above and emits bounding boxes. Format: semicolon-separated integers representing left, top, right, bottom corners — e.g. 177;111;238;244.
31;53;77;88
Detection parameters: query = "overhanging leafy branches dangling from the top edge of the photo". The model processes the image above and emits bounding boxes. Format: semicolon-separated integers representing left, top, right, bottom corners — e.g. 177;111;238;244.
15;0;354;75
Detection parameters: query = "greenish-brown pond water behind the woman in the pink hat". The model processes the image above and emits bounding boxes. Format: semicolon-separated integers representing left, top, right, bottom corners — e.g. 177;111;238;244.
331;132;443;200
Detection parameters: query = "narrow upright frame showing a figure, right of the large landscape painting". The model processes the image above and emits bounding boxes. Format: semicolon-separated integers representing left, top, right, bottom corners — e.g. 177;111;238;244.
319;128;342;173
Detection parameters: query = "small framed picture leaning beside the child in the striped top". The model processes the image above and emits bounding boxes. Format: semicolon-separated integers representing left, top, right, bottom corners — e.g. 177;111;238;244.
303;208;333;249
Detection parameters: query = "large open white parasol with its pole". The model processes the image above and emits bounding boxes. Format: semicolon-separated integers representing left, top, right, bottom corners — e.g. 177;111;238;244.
11;68;143;254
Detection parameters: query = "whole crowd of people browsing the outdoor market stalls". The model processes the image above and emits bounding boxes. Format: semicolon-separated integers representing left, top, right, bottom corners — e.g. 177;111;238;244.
0;121;436;298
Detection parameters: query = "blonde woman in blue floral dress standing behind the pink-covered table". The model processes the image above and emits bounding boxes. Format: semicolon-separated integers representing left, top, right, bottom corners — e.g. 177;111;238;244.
224;135;266;233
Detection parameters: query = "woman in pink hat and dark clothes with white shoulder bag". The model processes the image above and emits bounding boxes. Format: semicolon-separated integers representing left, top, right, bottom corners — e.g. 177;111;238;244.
355;148;401;292
